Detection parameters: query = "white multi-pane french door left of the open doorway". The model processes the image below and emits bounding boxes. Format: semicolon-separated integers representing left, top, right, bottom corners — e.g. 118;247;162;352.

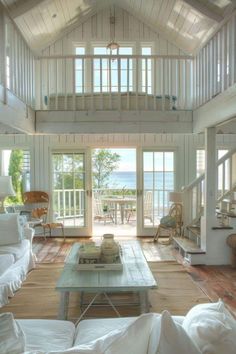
52;150;92;236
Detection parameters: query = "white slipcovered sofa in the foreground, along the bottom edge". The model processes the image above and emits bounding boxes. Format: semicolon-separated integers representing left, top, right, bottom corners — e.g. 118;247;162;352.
0;301;236;354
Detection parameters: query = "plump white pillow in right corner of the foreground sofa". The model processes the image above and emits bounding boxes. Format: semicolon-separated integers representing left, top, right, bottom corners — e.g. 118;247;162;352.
183;300;236;354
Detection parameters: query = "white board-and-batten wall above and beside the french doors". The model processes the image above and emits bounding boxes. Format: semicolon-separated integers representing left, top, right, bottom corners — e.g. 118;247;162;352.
0;134;236;192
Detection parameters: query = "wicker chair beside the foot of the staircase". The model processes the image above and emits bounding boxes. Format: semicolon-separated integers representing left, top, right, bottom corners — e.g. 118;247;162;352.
154;203;183;244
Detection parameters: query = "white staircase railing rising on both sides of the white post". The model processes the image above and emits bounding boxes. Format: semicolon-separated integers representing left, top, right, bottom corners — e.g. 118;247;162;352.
183;149;236;226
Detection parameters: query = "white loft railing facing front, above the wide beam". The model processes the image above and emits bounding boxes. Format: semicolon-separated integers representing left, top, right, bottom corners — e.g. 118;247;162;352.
36;55;193;111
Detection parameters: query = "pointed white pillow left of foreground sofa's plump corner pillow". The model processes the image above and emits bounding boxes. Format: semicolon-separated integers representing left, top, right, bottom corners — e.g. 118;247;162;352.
148;311;201;354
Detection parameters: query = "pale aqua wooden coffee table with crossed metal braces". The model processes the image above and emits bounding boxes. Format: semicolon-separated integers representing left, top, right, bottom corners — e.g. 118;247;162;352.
56;241;157;320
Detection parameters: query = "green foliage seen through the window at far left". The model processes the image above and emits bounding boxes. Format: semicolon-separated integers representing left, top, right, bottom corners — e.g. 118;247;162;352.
8;150;23;203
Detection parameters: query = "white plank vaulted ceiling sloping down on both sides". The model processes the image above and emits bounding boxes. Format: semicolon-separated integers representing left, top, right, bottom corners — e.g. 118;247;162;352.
1;0;236;53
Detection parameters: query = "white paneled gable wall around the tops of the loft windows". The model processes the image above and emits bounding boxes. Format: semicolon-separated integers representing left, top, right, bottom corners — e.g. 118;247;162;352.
42;7;186;56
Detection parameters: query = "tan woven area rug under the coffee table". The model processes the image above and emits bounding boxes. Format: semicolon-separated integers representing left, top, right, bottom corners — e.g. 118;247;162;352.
0;262;210;320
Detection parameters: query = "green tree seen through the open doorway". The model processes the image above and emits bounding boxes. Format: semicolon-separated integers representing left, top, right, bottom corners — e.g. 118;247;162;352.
92;149;120;189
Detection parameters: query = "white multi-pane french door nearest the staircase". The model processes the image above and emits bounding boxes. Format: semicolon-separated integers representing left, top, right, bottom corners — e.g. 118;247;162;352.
138;150;175;236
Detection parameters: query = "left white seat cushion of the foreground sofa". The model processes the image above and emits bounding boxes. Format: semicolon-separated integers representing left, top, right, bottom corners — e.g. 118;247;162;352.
18;320;75;353
